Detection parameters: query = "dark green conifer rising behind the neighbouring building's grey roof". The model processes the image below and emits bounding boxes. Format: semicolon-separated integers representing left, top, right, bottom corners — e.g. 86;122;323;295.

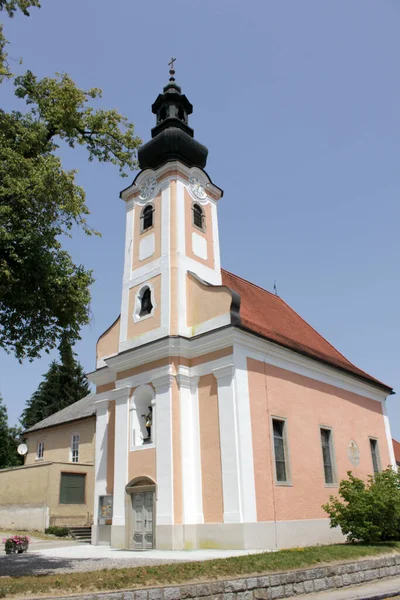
20;335;90;429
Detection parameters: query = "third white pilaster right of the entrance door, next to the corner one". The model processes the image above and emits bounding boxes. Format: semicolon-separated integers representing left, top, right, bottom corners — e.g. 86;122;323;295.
213;365;242;523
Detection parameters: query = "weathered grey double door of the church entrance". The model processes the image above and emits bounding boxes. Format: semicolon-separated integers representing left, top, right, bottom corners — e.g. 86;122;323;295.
132;492;154;550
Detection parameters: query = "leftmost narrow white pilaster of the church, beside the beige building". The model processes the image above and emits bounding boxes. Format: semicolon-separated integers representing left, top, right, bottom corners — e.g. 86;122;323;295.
93;400;108;525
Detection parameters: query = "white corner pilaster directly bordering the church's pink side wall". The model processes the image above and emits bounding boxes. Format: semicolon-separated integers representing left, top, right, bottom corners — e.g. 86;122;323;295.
233;345;257;523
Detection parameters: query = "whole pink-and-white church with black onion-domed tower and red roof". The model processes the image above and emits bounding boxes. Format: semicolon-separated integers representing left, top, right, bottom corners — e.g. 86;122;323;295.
88;69;395;550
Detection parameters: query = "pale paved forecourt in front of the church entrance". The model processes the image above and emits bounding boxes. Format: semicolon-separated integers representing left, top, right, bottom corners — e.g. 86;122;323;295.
0;541;257;577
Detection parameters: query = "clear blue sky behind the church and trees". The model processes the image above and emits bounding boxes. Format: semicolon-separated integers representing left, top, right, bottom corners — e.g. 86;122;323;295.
0;0;400;439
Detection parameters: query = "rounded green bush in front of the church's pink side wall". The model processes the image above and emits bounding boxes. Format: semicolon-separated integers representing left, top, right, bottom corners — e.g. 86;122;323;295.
322;467;400;542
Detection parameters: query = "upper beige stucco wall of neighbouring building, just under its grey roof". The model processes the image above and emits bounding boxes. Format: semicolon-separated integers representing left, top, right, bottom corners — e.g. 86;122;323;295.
25;417;96;465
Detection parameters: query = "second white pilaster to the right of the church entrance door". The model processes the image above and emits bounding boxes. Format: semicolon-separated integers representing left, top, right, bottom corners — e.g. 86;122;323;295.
177;373;204;525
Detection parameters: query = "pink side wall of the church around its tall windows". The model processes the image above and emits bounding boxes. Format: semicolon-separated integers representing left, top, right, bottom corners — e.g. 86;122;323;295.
247;358;390;521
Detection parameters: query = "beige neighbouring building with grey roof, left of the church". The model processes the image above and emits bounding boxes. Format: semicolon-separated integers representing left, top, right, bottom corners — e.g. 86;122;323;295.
0;395;96;531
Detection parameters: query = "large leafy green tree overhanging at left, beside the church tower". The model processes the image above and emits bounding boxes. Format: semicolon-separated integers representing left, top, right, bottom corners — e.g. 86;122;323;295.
0;0;141;360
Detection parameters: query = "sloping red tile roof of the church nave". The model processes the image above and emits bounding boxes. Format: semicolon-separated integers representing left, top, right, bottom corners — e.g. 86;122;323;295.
222;269;392;392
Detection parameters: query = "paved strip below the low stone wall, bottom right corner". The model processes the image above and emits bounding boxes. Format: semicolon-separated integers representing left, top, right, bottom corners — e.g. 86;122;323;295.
296;577;400;600
